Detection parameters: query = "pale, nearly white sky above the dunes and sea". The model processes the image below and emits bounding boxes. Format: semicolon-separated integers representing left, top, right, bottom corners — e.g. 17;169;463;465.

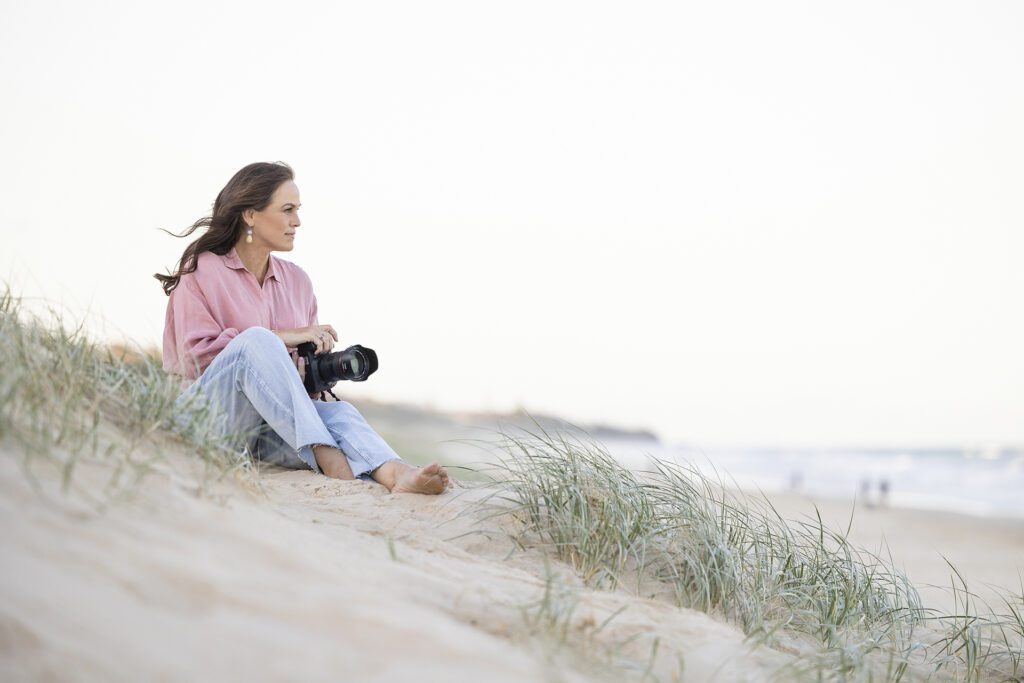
0;0;1024;445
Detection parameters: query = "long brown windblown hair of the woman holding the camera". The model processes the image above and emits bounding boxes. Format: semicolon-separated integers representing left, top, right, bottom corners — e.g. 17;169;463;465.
153;161;295;296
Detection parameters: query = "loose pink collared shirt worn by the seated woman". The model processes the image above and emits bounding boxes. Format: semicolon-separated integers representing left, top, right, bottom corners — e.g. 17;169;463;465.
164;247;317;386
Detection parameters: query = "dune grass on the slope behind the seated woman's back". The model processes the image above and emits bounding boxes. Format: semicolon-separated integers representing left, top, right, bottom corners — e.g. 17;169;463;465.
0;288;252;505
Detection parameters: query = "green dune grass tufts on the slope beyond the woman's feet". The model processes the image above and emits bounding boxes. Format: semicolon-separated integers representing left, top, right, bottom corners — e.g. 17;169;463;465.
473;425;1024;681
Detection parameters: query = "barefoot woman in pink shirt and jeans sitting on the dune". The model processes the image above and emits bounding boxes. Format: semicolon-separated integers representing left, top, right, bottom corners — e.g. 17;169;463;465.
155;162;449;494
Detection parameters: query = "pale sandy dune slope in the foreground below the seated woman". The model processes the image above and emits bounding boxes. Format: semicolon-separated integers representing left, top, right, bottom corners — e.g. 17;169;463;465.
0;444;787;682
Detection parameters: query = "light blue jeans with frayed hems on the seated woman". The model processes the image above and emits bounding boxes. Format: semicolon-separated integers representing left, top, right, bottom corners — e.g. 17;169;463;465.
177;328;398;478
